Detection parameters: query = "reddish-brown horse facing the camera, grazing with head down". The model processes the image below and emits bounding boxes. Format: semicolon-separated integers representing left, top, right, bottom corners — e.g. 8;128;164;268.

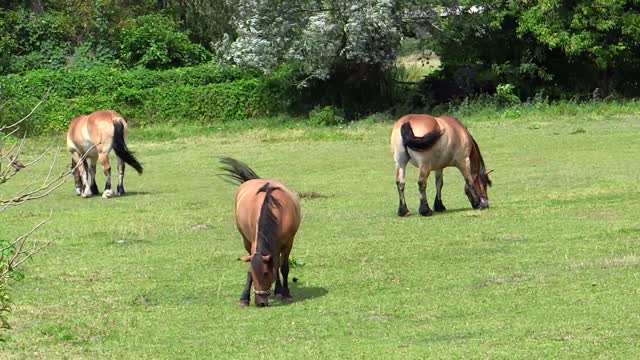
221;158;301;307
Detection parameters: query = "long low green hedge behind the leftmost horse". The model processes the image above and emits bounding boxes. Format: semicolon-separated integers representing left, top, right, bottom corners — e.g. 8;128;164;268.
0;65;292;134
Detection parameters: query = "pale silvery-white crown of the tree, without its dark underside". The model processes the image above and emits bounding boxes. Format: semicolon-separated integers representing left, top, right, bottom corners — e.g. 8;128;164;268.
219;0;401;79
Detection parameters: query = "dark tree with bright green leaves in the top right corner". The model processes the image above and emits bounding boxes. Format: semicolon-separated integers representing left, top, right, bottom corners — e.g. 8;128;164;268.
430;0;640;98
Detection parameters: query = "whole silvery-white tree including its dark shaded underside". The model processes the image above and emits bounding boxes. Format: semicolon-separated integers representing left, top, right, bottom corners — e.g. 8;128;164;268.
218;0;401;115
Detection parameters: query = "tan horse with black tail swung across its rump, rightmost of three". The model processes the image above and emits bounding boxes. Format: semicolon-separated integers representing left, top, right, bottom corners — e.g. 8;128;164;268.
391;114;491;216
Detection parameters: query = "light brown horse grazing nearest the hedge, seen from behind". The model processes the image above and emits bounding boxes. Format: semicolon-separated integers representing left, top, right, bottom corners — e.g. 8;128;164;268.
67;110;142;199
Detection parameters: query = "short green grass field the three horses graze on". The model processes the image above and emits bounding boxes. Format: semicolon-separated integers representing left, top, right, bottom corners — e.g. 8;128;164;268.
0;114;640;359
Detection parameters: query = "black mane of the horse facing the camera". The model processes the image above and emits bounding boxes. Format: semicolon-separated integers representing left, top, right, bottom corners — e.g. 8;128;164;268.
256;183;281;255
